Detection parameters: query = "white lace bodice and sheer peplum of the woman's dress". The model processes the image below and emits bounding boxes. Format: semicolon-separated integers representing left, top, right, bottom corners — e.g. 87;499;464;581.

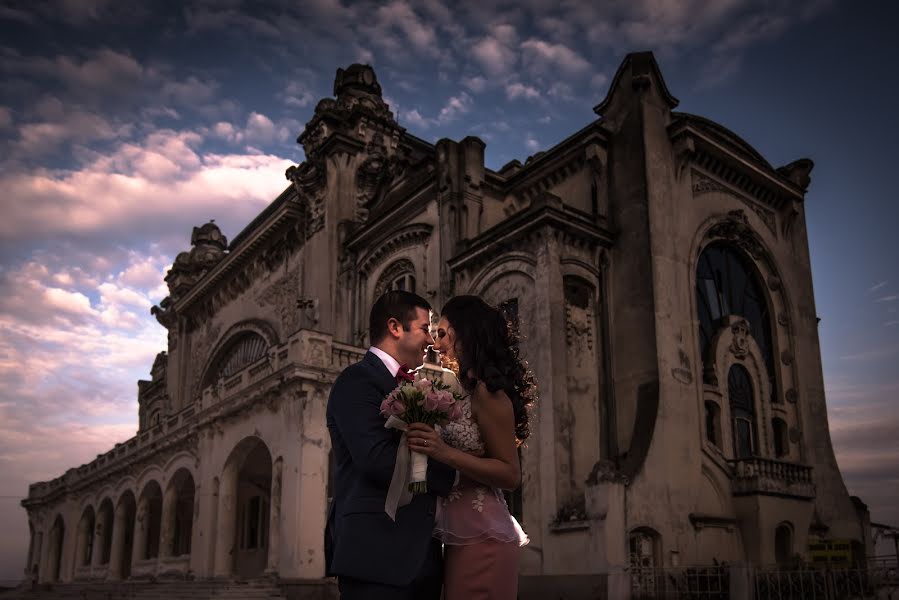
434;398;528;546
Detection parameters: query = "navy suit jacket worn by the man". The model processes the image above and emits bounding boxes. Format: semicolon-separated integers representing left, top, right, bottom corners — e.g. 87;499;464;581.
325;352;456;586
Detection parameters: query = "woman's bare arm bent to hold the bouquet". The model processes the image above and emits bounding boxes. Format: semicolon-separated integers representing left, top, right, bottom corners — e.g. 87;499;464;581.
407;381;521;490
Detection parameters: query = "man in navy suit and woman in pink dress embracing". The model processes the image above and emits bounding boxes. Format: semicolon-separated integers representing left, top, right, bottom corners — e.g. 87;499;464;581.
325;291;535;600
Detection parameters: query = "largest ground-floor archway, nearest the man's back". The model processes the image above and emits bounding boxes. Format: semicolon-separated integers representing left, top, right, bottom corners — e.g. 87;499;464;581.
215;436;272;578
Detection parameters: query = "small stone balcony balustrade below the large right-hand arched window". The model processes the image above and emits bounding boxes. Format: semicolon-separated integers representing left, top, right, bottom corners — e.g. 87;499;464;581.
729;457;815;499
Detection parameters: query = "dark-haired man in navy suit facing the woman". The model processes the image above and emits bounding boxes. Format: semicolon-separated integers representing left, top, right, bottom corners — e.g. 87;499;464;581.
325;291;456;600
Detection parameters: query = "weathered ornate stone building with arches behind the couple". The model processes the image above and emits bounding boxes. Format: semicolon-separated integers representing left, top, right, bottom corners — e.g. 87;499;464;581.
17;53;869;597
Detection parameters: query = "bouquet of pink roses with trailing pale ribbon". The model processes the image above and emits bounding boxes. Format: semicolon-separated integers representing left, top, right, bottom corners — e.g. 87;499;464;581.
381;379;463;496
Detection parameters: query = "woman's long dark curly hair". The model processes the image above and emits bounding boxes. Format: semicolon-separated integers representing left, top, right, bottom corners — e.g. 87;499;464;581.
441;296;536;443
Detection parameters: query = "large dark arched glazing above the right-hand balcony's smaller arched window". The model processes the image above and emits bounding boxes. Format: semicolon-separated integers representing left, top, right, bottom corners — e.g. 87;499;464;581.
696;242;777;401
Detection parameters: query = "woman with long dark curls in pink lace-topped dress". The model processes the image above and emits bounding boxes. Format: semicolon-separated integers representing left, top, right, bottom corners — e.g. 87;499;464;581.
408;296;535;600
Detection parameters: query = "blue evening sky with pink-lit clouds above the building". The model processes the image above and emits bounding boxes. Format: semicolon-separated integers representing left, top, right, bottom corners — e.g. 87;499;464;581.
0;0;899;579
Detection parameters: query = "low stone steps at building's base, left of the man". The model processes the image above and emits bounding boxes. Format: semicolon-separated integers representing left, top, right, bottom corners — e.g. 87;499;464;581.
0;579;326;600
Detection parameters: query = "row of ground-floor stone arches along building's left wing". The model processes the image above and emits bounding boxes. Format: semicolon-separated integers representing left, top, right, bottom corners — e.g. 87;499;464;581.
27;436;280;582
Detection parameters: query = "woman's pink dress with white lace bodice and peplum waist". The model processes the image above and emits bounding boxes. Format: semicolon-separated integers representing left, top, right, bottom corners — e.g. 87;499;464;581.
434;398;528;600
